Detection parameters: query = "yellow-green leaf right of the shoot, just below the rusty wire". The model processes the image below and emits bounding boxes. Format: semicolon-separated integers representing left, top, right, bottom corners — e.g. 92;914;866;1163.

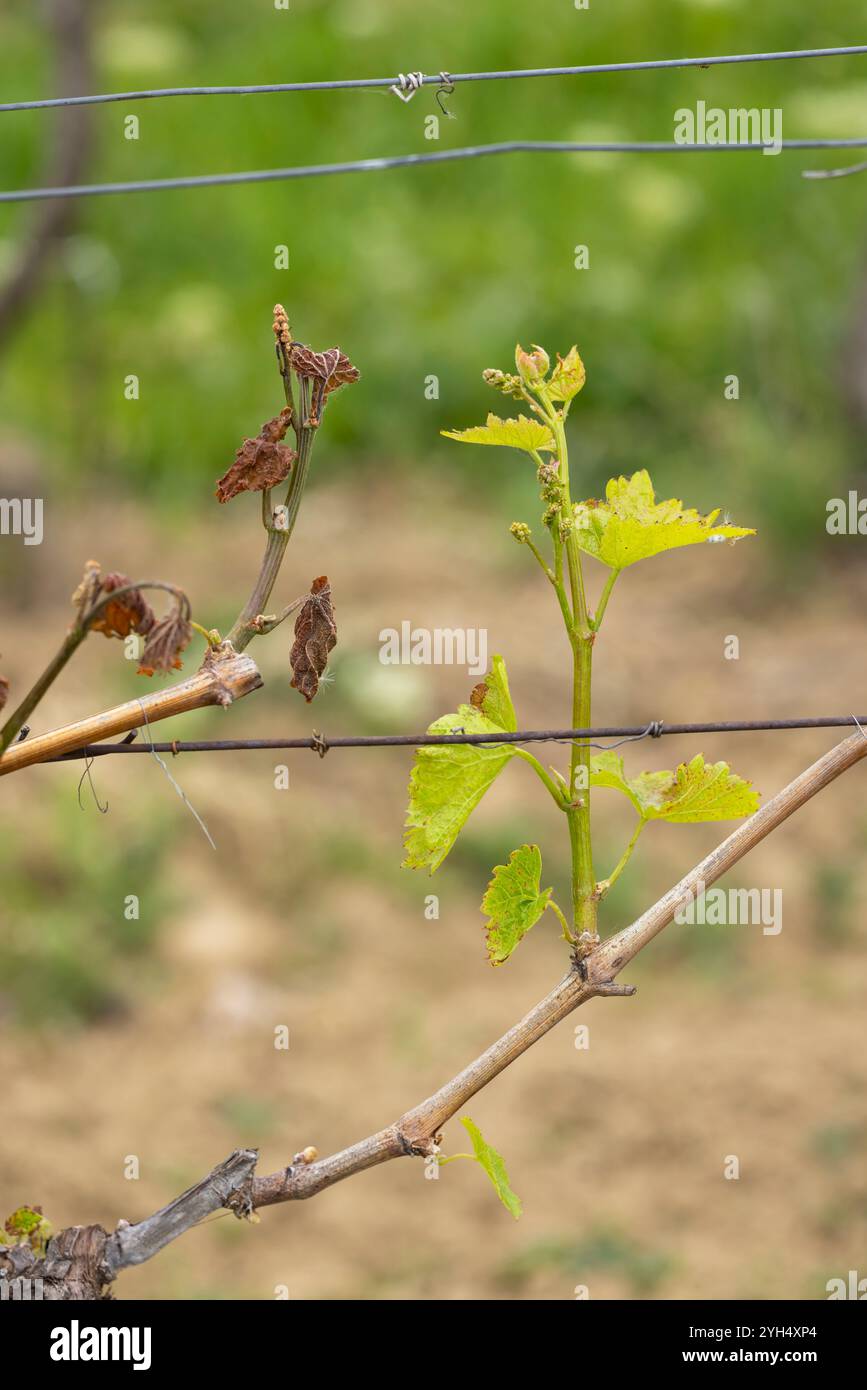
591;751;759;826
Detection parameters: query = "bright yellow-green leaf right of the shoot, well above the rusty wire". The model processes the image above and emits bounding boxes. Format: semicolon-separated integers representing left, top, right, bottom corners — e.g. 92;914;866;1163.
575;468;756;570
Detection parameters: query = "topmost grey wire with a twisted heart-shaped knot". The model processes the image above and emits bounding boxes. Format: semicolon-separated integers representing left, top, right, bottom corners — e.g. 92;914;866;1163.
0;43;867;113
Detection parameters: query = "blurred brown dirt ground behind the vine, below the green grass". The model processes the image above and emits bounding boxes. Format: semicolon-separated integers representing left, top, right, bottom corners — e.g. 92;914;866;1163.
0;484;867;1300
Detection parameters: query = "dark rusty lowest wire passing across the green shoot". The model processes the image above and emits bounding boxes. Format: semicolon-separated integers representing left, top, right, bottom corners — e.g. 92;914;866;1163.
43;714;867;763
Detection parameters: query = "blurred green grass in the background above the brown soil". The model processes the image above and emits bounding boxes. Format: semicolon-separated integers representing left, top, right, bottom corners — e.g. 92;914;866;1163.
0;0;867;550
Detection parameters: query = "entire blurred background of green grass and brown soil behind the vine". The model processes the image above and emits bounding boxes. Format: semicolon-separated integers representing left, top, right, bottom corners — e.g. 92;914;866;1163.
0;0;867;1300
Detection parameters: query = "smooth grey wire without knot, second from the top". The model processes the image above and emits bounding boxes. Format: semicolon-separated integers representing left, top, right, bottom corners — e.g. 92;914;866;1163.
0;136;867;203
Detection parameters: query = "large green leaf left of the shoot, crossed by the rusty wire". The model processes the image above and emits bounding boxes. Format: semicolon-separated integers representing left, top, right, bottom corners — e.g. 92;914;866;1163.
403;656;518;873
